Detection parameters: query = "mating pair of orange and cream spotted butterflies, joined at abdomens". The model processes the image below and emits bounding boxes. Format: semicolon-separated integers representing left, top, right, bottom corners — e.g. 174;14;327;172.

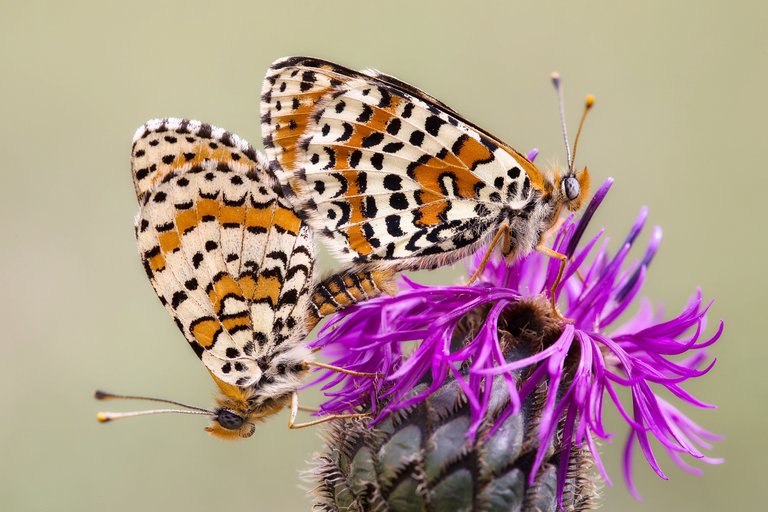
97;57;589;438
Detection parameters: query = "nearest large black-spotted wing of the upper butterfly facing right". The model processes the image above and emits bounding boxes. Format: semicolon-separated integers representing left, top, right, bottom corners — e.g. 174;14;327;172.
289;80;532;268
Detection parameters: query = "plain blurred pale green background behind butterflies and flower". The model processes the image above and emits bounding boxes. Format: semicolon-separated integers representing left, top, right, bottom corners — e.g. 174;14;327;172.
0;0;768;512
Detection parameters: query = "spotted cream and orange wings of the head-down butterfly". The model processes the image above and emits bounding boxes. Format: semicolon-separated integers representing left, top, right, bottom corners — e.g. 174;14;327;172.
132;119;314;386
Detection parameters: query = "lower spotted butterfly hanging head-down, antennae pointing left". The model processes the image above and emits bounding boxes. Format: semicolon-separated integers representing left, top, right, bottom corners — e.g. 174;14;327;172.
96;119;393;439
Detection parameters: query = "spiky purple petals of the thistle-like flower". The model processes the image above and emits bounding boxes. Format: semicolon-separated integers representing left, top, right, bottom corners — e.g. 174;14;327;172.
304;179;723;500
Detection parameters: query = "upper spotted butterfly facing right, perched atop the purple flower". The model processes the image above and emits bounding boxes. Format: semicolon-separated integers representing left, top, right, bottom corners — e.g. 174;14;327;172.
261;57;593;311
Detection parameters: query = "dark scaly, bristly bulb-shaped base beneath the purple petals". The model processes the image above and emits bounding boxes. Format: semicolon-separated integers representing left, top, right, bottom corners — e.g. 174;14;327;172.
305;352;597;512
